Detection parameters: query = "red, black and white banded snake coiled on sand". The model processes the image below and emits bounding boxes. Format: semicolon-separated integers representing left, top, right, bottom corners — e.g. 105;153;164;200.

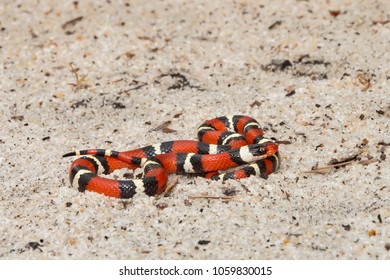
63;115;280;198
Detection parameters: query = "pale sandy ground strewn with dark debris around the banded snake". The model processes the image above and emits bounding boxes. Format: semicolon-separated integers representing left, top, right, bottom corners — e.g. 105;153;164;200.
0;0;390;259
